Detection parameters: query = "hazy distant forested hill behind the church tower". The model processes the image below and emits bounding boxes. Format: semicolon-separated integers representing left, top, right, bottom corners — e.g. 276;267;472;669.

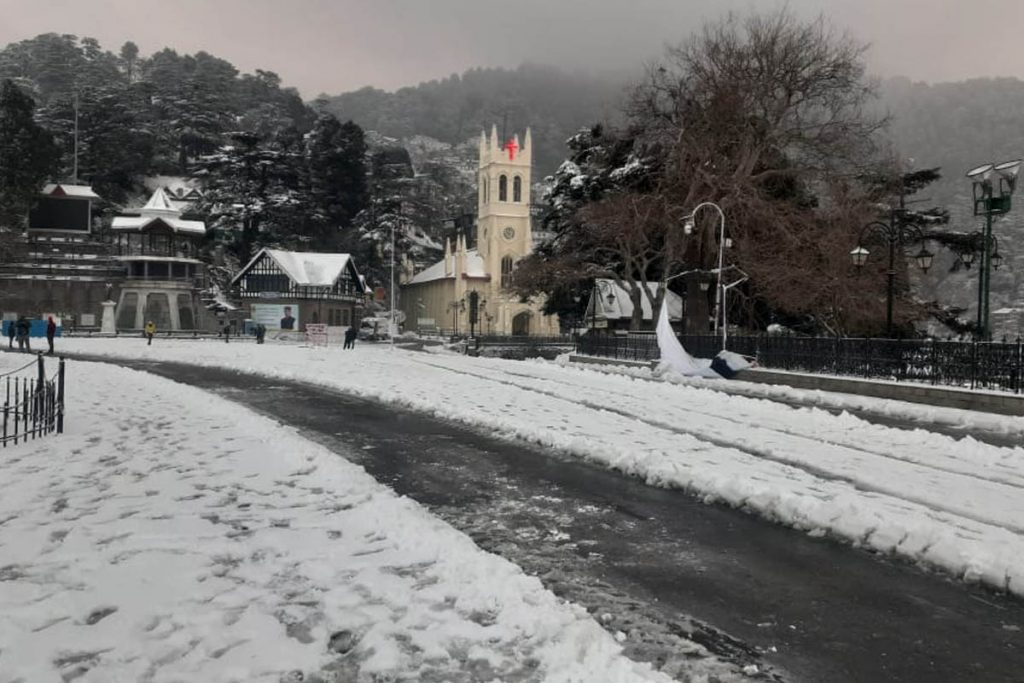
321;65;626;179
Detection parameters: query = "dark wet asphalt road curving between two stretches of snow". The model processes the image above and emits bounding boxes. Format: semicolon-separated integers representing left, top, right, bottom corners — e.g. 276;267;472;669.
92;362;1024;683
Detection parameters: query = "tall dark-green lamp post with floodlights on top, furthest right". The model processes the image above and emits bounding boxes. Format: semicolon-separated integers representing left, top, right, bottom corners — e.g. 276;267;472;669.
967;159;1022;339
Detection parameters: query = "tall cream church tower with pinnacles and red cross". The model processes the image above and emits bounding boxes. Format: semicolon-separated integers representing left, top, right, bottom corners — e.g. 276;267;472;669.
476;127;534;291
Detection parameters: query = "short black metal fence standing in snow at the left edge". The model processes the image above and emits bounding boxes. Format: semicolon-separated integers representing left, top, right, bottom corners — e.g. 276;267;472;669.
0;353;65;447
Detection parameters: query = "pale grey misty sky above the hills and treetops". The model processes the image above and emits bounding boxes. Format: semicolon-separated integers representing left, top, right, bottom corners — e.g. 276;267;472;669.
0;0;1024;98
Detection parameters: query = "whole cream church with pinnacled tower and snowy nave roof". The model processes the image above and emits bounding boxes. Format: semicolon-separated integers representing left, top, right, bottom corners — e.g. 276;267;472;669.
400;127;559;335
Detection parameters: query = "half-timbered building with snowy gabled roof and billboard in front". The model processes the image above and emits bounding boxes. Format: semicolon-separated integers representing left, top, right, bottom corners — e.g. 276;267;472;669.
231;249;367;332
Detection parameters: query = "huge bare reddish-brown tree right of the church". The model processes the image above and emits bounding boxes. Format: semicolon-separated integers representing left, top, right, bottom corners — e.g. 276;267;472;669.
520;10;885;330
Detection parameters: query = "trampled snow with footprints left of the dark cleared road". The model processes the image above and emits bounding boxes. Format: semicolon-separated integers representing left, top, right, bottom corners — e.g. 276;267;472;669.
0;358;670;683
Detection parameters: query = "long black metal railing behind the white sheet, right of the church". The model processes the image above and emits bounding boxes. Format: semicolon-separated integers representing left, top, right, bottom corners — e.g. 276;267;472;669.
577;333;1024;393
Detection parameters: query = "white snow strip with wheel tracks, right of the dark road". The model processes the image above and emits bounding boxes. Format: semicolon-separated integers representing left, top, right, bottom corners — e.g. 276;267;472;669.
51;339;1024;595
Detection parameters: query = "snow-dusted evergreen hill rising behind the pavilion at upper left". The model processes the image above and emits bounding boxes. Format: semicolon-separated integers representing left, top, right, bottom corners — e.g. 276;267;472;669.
0;34;316;202
